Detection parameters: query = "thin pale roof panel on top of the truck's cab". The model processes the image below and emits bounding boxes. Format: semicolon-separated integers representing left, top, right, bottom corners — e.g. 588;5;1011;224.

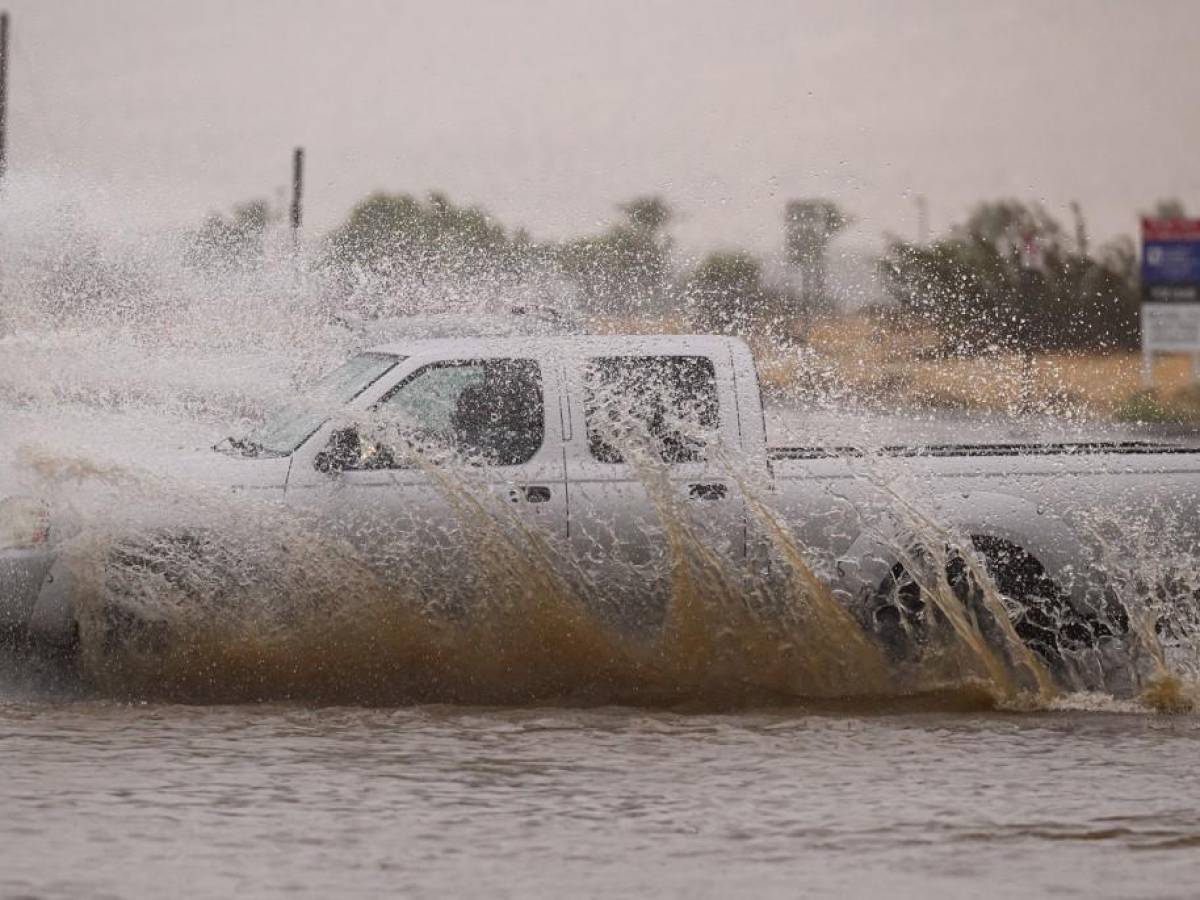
360;335;745;356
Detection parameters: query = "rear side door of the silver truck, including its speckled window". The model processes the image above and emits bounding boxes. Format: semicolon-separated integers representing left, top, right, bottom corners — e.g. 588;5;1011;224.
566;353;745;626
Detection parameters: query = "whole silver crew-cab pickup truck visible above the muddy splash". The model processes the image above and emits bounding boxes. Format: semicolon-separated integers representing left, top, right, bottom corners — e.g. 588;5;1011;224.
0;336;1200;686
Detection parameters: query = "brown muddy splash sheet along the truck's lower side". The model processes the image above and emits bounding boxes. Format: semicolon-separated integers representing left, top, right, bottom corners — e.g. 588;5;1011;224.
18;441;1190;710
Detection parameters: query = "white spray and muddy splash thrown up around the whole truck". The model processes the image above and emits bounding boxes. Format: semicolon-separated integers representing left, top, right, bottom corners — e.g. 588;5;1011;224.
0;174;1198;710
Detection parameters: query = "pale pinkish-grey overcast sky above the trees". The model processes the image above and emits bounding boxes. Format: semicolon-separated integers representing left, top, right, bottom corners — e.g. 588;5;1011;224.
7;0;1200;251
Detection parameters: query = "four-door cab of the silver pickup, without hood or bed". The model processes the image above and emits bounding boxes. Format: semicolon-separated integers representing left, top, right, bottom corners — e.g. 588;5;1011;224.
274;336;766;620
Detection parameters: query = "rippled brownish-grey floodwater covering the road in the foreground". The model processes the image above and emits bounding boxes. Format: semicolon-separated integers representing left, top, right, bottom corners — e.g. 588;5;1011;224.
0;696;1200;898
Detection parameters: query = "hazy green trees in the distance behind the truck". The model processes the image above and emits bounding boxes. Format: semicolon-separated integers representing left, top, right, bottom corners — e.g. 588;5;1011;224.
188;193;1183;354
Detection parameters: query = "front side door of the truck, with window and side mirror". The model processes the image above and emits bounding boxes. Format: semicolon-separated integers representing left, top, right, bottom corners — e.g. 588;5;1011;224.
289;356;566;606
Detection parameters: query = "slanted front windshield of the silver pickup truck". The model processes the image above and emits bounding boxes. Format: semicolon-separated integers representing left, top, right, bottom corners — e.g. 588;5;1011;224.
238;353;404;456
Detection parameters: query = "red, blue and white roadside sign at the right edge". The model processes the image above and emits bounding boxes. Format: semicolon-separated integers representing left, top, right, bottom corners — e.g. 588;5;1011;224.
1141;218;1200;388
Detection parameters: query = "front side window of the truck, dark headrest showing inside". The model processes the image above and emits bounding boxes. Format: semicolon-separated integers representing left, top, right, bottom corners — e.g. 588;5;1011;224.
374;359;546;466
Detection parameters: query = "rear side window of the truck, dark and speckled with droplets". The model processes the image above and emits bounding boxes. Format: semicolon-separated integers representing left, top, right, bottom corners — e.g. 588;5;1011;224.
583;356;720;464
